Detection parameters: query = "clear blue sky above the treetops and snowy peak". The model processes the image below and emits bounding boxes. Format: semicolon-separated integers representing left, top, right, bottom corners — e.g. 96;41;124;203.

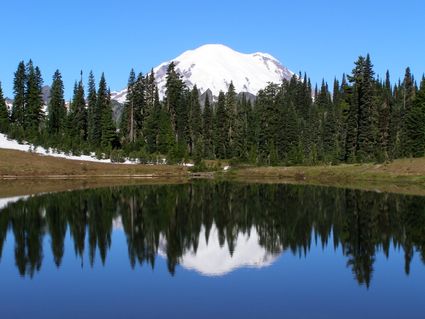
0;0;425;98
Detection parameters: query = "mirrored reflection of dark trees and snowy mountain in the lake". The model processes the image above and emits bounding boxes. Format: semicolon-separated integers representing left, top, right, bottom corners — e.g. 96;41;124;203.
0;182;425;286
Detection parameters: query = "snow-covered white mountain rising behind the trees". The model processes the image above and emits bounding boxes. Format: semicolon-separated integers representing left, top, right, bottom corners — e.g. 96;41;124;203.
112;44;293;103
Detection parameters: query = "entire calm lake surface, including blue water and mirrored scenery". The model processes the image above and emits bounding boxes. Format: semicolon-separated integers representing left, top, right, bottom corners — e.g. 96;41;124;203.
0;181;425;319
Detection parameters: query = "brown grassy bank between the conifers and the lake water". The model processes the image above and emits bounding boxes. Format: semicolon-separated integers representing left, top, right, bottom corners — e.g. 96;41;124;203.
0;149;425;198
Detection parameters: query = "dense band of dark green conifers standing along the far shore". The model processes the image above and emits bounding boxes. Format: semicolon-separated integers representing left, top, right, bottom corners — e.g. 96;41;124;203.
0;55;425;165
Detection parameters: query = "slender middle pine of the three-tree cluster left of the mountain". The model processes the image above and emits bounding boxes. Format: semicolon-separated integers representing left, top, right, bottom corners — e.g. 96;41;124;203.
87;71;100;146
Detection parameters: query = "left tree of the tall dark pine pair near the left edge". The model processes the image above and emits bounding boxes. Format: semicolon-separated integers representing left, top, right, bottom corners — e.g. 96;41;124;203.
11;61;27;127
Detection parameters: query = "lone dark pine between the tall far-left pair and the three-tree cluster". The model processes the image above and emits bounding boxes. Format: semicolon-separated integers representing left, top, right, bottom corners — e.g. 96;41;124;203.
47;70;66;135
